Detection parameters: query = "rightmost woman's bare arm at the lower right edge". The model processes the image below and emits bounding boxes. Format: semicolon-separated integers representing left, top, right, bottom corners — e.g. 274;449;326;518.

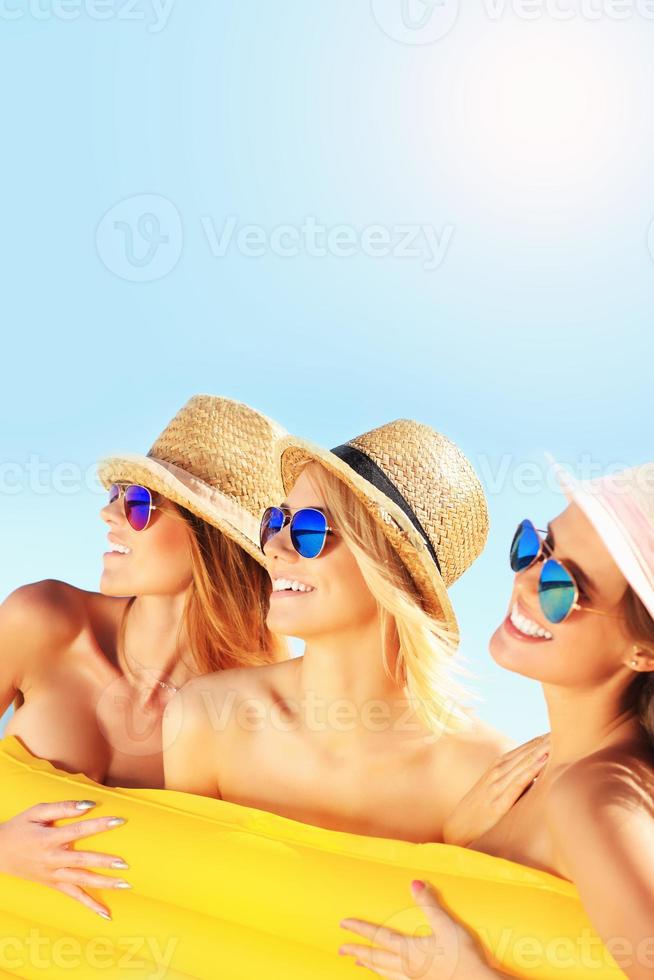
547;759;654;980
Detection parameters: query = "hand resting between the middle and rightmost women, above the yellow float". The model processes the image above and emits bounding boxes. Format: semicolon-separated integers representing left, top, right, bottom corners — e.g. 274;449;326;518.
443;733;550;847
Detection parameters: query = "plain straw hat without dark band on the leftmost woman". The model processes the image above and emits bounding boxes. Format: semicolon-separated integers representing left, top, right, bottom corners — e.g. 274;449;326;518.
98;395;286;565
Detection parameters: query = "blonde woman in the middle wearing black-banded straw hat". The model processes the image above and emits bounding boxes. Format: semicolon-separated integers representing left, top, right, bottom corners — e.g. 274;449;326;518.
164;420;542;841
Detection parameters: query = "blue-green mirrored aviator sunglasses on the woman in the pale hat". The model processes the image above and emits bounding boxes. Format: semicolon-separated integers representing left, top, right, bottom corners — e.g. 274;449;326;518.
510;520;611;623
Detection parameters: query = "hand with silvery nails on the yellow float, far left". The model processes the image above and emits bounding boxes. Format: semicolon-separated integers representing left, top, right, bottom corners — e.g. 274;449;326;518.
0;800;131;919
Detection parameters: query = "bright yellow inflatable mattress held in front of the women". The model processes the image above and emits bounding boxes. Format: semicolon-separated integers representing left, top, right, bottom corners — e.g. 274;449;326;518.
0;736;623;980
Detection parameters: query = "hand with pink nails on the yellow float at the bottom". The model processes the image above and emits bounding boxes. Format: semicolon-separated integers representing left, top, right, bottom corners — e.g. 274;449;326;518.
339;881;508;980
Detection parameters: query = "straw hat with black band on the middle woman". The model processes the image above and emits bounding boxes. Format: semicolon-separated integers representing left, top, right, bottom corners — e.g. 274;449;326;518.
276;419;488;632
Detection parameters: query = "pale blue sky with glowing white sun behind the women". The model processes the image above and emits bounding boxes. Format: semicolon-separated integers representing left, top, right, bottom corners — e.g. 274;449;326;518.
0;0;654;739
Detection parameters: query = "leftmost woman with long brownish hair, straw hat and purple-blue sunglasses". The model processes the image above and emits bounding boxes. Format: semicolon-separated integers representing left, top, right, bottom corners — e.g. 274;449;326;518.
0;395;288;917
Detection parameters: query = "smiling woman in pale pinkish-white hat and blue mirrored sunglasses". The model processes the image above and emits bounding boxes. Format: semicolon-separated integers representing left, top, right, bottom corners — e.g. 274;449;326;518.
342;463;654;980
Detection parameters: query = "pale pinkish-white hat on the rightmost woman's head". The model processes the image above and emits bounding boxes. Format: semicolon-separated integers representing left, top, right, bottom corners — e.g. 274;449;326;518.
555;463;654;619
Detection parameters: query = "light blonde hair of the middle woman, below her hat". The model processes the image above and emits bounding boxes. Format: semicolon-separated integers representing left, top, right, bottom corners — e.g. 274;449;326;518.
303;462;470;733
